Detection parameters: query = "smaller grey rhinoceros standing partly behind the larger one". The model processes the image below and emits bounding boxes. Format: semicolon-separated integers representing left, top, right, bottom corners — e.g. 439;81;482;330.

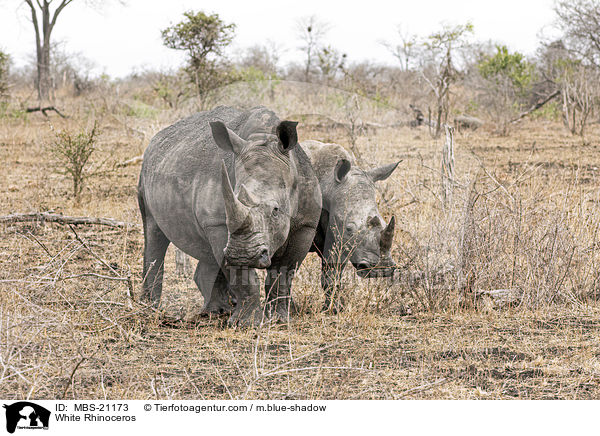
301;140;400;311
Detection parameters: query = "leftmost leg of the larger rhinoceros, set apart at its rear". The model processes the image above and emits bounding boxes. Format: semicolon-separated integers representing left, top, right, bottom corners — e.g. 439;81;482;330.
141;212;169;307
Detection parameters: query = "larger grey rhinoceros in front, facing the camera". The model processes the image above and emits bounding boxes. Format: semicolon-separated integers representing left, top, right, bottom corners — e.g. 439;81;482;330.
138;106;321;325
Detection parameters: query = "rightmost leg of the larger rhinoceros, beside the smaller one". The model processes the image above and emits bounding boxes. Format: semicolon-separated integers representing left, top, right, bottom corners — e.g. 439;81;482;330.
265;227;315;321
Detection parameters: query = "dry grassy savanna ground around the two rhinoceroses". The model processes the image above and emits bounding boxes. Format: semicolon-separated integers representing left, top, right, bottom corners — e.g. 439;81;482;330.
0;84;600;399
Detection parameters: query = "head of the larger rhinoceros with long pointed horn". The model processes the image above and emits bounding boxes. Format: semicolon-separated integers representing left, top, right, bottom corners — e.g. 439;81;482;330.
211;121;298;268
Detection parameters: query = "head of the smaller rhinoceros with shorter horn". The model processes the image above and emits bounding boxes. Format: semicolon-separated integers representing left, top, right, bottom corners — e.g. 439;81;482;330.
327;159;400;277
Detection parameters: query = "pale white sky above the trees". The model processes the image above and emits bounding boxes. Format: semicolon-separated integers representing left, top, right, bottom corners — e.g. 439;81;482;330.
0;0;554;76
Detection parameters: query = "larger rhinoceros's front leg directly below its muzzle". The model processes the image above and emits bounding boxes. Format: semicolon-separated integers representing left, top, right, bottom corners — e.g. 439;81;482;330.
226;266;264;327
